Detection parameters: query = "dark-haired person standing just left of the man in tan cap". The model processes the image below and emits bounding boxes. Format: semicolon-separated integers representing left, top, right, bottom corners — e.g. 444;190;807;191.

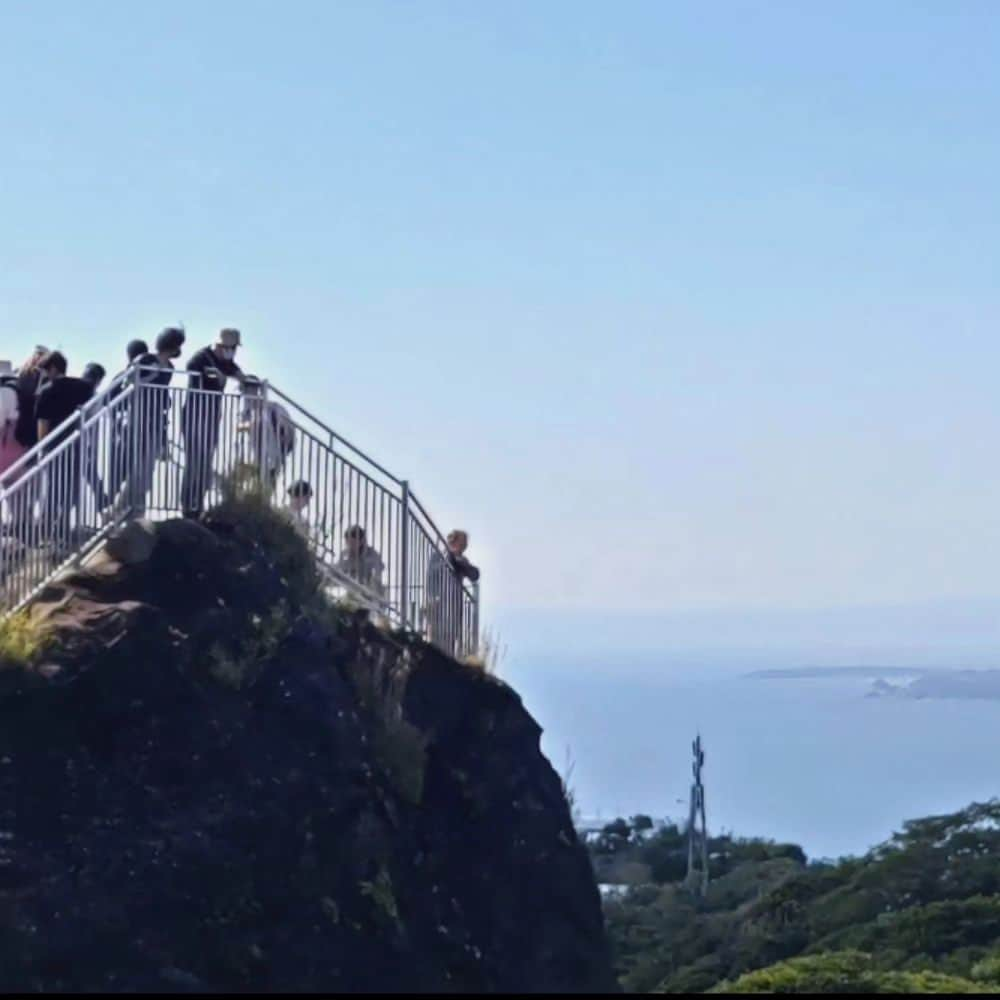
119;326;185;517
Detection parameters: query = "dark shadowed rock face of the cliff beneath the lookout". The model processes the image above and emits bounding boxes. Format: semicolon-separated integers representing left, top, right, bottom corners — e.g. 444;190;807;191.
0;521;616;992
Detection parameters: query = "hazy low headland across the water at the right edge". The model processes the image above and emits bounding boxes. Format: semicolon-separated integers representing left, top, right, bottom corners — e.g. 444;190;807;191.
746;667;1000;701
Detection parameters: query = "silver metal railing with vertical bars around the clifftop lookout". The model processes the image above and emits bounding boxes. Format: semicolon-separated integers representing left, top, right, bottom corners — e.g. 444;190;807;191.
0;368;479;656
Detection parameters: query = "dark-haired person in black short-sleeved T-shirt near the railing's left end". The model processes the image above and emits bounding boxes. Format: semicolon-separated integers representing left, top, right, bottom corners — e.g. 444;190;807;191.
35;351;94;543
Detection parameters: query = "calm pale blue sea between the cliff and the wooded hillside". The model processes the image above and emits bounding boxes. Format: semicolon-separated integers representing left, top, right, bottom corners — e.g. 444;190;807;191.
500;647;1000;858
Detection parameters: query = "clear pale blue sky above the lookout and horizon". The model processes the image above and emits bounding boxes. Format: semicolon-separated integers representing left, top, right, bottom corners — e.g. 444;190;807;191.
0;0;1000;612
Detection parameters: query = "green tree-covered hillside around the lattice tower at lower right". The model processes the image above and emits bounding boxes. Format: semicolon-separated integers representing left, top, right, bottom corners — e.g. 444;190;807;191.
590;802;1000;993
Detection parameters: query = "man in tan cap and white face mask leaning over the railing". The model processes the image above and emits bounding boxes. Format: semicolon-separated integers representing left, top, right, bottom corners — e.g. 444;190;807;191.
181;327;243;517
